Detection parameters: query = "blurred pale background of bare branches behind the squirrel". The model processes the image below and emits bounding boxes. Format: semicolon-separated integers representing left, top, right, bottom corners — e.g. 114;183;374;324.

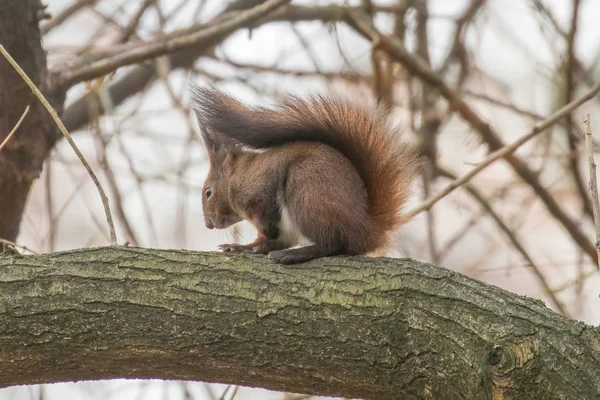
0;0;600;400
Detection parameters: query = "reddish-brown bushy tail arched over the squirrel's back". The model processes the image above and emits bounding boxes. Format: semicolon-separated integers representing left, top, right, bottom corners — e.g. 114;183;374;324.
193;87;419;231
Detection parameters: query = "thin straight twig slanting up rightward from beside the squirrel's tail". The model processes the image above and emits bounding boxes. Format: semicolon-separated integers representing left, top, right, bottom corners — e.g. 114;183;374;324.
408;82;600;218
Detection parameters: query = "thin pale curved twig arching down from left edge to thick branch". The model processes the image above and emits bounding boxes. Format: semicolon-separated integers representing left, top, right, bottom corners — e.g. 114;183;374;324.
0;44;117;245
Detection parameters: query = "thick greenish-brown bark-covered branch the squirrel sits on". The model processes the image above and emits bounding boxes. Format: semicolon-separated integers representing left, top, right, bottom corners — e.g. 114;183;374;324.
0;247;600;399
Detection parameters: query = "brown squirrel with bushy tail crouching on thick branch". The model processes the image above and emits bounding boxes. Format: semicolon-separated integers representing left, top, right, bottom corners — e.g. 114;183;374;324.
192;87;419;264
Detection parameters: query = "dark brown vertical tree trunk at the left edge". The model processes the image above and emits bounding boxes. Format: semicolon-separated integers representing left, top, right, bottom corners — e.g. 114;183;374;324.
0;0;64;244
